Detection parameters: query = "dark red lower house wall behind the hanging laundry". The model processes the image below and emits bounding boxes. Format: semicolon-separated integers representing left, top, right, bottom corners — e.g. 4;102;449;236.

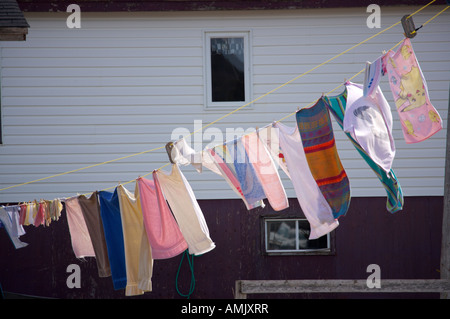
0;197;443;299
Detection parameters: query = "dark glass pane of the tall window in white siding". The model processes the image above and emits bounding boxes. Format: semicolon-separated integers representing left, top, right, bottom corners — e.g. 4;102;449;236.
211;38;245;102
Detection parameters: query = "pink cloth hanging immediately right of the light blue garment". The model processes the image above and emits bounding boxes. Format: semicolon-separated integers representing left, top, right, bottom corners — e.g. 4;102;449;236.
242;132;289;211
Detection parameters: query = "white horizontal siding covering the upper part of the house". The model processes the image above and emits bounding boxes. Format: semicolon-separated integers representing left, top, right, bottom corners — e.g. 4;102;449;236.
0;6;450;202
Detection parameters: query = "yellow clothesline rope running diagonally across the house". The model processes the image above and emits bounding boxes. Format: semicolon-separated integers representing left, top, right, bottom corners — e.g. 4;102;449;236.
0;0;442;198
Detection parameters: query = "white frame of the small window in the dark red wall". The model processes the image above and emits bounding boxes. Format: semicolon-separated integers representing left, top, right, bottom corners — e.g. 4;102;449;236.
264;218;332;255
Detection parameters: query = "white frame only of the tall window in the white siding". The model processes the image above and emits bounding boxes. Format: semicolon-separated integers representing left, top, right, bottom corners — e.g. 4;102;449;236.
203;30;253;110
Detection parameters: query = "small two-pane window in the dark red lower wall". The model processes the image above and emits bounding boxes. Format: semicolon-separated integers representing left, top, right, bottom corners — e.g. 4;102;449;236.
264;218;333;255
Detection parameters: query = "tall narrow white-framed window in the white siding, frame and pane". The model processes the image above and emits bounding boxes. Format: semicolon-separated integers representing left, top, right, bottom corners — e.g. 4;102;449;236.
205;32;250;108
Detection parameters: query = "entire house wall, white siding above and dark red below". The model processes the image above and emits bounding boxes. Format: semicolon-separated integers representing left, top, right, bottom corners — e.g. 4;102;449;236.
0;6;450;299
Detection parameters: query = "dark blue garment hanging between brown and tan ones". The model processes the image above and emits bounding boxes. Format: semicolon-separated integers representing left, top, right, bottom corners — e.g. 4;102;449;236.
98;189;127;290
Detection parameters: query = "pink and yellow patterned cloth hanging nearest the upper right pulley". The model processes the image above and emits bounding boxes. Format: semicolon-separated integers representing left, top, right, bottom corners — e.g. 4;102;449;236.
383;38;442;143
